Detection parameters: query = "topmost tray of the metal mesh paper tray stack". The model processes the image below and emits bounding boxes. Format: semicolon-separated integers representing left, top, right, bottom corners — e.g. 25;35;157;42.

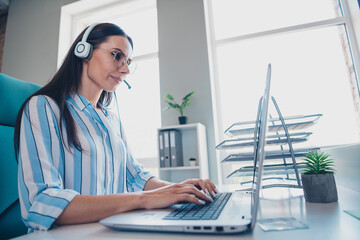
225;114;322;137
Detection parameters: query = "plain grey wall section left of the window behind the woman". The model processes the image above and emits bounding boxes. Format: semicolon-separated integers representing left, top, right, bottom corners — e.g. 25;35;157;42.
2;0;76;85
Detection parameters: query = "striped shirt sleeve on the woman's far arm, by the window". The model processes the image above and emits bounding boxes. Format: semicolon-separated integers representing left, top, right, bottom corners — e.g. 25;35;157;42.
116;115;154;192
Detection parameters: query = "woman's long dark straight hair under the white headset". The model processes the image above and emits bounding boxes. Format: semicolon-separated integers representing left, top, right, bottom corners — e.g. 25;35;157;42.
14;23;133;155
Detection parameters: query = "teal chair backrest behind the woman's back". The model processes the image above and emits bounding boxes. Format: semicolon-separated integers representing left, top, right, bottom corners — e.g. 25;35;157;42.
0;73;40;239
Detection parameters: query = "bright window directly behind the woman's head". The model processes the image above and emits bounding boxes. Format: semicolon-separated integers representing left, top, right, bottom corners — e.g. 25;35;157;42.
59;0;161;174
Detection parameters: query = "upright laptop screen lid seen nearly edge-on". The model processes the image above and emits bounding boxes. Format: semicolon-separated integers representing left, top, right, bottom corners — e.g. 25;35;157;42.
251;63;271;229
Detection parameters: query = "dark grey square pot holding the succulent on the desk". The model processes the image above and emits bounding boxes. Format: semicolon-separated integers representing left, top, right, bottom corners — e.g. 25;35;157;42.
301;173;338;203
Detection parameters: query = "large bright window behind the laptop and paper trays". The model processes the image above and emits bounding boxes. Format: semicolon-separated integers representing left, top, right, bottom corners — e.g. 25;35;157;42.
209;0;360;183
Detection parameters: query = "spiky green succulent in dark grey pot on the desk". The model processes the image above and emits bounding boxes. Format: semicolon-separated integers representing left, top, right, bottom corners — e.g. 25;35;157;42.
301;151;338;203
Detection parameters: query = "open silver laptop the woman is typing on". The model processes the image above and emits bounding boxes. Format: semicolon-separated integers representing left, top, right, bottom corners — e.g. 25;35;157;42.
100;64;271;234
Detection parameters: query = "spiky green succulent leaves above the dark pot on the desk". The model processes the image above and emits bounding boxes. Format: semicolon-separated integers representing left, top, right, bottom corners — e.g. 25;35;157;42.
303;151;335;174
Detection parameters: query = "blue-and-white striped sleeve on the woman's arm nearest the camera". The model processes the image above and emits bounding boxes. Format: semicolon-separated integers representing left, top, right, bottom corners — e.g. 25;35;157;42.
18;96;79;231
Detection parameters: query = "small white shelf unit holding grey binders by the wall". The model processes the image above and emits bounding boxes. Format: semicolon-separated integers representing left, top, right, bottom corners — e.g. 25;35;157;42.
157;123;209;182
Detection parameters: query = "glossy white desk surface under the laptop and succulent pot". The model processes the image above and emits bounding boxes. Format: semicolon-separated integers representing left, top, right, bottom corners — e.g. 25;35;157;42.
12;186;360;240
